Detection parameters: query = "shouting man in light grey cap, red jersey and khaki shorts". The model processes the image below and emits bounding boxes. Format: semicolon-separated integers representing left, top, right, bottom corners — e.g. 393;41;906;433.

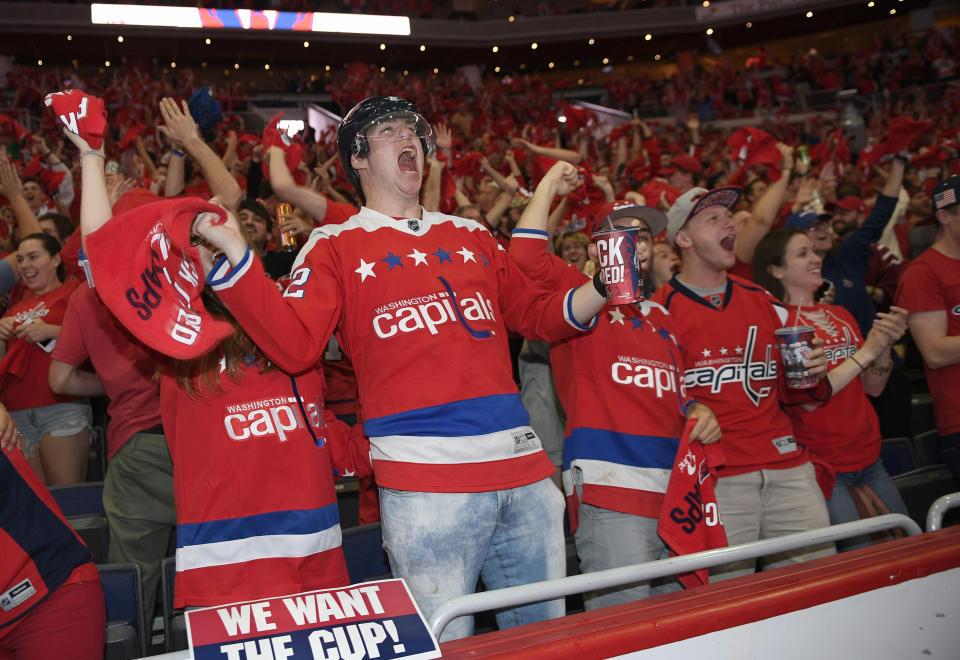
653;187;835;579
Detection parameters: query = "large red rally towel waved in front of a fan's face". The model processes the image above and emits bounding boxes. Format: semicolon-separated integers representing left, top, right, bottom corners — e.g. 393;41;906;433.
85;197;236;360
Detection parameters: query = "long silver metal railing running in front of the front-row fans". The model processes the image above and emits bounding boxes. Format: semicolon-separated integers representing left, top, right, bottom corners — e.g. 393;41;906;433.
428;513;923;639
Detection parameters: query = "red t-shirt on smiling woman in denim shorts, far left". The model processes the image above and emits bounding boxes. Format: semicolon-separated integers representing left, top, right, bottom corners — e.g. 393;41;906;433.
0;280;77;410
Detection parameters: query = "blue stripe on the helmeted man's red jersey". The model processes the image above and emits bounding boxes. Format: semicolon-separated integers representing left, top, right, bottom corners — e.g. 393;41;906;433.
363;394;530;438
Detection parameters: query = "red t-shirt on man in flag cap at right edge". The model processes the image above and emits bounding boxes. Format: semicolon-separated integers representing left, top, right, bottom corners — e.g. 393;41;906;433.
897;248;960;435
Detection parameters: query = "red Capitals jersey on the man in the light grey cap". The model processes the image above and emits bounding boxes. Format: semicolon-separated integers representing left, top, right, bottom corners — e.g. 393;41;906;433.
653;275;806;477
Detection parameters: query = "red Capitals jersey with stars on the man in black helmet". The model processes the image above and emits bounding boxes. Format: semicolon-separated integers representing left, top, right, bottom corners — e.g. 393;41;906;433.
208;207;584;492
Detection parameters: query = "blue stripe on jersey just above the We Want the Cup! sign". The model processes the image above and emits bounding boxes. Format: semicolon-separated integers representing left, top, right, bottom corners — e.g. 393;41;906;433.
177;502;340;548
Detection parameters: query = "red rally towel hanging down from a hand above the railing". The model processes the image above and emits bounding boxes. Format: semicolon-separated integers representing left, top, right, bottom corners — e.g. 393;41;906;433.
657;418;727;589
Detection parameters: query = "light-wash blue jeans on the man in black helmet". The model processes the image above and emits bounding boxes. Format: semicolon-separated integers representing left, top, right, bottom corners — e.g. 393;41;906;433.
380;479;566;641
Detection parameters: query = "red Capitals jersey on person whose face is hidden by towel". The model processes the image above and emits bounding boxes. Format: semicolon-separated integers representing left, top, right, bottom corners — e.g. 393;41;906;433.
160;364;369;607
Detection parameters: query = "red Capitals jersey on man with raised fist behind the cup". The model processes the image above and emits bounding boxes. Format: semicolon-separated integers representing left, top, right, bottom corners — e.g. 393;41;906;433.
510;229;686;530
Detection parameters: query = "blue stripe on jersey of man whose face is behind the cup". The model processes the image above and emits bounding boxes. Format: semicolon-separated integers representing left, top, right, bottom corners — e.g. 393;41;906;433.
563;428;680;470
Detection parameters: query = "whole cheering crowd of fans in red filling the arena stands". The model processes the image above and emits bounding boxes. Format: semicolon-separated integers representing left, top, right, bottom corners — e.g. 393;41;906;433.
0;23;960;657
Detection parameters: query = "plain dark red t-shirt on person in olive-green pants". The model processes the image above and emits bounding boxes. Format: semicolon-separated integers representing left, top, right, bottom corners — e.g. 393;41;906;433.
51;285;160;458
